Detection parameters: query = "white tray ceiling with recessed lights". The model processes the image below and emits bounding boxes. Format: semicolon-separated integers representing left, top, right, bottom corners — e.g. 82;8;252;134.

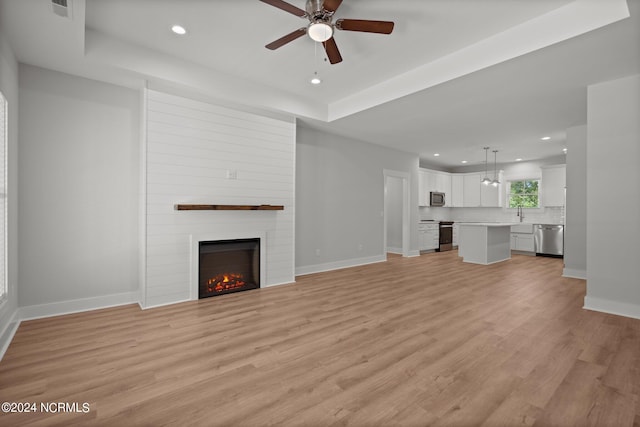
0;0;640;168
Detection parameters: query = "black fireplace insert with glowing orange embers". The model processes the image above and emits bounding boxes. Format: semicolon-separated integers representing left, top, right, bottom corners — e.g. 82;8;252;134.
198;238;260;298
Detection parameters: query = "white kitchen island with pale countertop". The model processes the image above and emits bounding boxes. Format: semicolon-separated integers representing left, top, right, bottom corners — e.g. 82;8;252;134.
458;222;513;265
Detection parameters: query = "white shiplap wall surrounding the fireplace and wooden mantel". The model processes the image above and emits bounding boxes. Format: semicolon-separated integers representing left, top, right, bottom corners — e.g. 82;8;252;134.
141;90;296;307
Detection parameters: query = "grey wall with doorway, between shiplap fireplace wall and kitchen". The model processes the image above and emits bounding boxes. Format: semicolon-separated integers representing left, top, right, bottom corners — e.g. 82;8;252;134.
296;125;419;275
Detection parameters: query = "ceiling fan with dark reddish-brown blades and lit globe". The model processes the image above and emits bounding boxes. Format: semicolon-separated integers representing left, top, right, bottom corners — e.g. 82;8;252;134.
260;0;393;64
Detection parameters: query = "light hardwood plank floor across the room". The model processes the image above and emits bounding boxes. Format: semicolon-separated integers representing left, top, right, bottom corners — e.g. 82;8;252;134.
0;251;640;427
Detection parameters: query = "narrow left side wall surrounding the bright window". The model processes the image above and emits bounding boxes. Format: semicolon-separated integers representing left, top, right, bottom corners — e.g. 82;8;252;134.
0;33;19;358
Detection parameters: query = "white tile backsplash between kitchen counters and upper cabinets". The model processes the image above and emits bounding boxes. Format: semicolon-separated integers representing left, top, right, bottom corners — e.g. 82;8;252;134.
420;207;565;224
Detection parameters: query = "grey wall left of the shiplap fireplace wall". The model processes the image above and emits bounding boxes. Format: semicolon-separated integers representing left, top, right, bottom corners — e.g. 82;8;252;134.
19;64;140;317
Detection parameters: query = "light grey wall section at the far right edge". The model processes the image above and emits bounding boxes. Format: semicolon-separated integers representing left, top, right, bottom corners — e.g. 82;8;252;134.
585;75;640;318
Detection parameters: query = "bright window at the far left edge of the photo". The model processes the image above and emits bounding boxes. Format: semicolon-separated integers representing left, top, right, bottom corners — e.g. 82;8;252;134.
0;92;7;301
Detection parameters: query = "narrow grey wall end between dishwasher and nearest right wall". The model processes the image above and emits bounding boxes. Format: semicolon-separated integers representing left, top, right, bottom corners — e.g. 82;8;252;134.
563;126;587;279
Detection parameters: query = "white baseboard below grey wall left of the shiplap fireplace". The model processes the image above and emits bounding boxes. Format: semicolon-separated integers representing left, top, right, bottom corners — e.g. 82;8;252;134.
19;291;140;320
